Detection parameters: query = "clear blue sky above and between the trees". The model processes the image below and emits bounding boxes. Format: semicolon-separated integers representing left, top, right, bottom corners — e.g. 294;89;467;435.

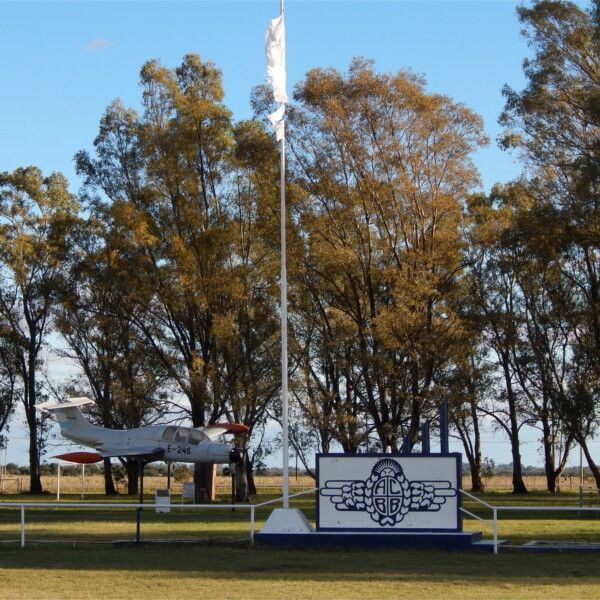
0;0;575;464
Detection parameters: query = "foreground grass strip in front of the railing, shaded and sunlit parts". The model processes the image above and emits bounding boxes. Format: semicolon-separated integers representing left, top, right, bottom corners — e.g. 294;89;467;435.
0;544;600;600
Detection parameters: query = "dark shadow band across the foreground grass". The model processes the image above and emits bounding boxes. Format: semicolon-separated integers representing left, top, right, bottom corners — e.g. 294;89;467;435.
0;544;600;585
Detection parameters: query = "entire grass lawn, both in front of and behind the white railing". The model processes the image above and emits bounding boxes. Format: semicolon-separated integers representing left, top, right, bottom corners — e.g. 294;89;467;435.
0;494;600;600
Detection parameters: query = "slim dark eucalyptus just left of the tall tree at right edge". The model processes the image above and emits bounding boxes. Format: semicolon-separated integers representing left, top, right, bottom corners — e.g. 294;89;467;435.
511;202;574;492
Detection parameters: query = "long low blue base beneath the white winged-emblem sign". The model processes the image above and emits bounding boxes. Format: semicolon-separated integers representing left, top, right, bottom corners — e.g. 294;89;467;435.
254;531;493;552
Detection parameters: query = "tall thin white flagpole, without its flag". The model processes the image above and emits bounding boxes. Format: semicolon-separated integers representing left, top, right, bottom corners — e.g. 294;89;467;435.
279;0;290;508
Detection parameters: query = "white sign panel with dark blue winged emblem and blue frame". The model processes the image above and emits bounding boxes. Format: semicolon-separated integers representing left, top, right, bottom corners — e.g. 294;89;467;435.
317;454;461;532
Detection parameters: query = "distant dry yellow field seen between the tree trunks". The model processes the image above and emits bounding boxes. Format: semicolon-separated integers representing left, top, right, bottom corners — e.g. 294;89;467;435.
0;475;594;495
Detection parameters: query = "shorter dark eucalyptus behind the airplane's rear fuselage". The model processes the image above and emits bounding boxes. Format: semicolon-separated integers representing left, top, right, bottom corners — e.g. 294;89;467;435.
57;215;167;494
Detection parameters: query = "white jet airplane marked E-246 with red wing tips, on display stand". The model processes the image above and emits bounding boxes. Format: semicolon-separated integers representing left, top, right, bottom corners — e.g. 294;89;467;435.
37;398;248;463
